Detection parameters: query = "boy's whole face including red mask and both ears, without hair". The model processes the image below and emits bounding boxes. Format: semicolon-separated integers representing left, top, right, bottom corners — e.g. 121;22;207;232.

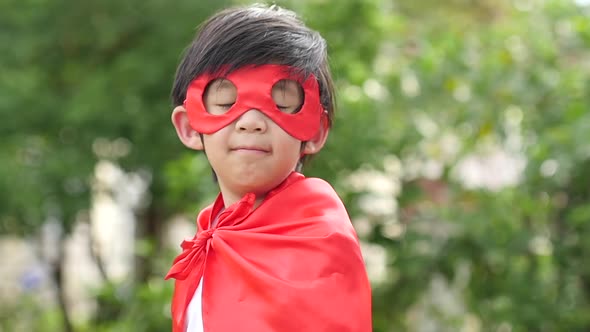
172;65;328;206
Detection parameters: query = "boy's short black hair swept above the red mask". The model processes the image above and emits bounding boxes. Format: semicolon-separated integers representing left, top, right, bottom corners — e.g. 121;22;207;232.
172;4;335;170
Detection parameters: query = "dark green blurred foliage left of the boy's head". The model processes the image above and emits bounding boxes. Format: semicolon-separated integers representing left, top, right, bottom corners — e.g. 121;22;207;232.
0;0;235;234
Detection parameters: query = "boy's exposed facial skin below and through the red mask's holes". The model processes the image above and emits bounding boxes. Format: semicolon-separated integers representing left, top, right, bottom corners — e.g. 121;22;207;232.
203;79;303;199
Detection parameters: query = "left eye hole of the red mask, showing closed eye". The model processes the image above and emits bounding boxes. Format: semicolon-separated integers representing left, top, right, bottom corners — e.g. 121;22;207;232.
203;78;238;114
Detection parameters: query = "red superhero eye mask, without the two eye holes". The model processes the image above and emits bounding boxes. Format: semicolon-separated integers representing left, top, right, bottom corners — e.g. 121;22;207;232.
184;65;323;141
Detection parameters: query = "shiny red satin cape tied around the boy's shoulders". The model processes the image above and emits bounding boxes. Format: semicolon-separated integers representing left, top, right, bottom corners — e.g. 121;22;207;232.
166;172;372;332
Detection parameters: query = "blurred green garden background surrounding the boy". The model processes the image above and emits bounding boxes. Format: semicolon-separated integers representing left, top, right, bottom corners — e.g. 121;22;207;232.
0;0;590;332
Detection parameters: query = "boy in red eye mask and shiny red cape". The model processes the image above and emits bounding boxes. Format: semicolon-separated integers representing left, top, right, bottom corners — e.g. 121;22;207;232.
166;6;371;332
